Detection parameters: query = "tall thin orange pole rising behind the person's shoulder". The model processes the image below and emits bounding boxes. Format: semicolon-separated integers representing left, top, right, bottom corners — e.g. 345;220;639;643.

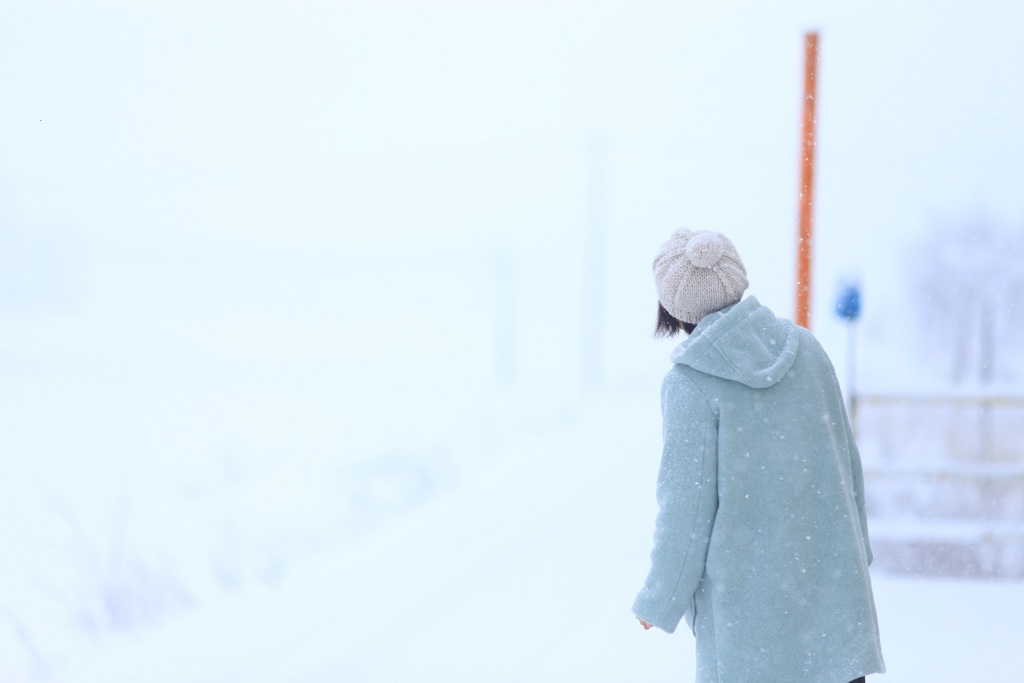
796;32;818;329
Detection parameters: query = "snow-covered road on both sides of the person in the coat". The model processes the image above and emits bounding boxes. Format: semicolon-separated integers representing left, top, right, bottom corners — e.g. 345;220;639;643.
53;402;1024;683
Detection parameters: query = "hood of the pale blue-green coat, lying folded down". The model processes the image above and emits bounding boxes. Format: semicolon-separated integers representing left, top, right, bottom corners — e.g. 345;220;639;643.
672;296;800;389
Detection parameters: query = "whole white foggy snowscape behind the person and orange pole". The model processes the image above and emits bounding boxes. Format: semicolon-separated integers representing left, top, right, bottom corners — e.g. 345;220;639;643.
0;0;1024;681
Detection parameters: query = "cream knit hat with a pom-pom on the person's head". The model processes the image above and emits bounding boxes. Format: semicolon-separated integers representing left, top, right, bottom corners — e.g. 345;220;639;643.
653;230;749;324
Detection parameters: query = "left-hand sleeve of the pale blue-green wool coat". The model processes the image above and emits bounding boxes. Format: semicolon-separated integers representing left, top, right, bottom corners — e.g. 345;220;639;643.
633;372;718;633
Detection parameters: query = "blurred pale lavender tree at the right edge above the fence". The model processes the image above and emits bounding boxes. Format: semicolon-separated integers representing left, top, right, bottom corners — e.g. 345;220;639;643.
908;214;1024;384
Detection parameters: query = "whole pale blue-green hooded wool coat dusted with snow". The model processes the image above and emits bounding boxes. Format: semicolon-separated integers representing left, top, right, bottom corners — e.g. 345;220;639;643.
633;297;885;683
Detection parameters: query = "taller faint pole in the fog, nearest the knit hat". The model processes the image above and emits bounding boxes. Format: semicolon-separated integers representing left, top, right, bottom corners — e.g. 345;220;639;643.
580;137;608;390
